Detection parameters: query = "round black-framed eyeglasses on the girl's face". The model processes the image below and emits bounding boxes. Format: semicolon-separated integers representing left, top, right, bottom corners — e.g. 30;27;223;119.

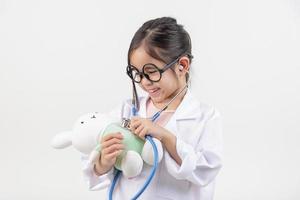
126;56;181;83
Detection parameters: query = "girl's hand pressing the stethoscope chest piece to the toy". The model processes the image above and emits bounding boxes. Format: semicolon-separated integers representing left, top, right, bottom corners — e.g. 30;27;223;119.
130;117;165;140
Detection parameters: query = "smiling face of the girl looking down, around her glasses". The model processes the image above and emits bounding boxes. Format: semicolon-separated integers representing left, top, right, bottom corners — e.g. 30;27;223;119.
130;47;185;104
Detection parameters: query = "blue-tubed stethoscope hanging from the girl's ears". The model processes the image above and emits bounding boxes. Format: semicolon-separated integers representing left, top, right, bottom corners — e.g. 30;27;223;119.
109;83;188;200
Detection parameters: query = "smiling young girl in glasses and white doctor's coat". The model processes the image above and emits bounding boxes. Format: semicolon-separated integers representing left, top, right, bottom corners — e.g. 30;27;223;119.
82;17;222;200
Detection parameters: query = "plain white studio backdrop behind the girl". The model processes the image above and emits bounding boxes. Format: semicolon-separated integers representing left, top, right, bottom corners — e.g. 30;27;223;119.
0;0;300;200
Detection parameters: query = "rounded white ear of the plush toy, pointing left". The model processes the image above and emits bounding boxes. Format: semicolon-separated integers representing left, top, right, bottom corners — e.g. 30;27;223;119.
51;131;73;149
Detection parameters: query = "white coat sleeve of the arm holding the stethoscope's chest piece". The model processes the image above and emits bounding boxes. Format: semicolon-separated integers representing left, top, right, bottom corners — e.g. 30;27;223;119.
165;110;222;186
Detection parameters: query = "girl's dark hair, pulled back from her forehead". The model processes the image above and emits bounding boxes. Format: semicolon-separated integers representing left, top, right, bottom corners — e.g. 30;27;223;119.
128;17;193;81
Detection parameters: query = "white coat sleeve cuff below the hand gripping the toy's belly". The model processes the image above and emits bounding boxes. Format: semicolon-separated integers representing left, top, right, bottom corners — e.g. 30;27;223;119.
81;154;114;191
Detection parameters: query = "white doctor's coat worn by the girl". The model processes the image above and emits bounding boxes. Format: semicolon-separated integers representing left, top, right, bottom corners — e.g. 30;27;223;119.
81;90;222;200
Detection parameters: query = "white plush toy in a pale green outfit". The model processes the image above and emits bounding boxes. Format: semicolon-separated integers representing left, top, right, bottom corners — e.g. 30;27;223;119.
51;112;163;178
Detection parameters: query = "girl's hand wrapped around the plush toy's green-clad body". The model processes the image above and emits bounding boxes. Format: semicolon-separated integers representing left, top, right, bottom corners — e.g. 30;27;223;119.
96;133;124;171
